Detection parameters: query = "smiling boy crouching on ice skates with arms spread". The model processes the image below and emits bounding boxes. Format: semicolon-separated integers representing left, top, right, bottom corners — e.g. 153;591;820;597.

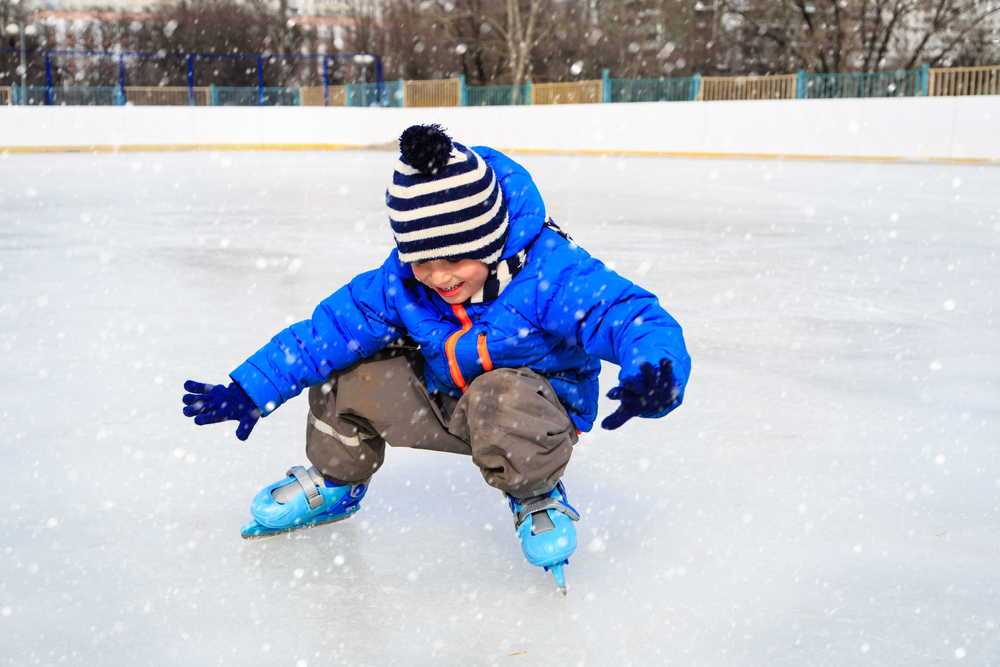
184;125;691;594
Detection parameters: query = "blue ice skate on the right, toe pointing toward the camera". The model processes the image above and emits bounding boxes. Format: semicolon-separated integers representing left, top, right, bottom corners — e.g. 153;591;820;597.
507;481;580;595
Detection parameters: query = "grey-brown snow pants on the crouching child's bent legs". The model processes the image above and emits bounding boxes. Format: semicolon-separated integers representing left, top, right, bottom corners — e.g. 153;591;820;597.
306;347;578;497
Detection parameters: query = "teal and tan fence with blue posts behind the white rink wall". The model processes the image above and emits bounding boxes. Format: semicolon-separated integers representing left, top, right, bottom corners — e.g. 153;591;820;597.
9;66;1000;107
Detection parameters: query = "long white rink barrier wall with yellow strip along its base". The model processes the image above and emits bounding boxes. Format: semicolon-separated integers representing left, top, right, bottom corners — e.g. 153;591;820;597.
0;96;1000;162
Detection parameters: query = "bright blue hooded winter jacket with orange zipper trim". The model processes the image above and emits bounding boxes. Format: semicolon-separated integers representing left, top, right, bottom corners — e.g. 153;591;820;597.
231;146;691;431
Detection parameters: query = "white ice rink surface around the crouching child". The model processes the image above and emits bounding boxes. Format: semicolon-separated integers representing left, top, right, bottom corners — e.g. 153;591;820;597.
0;151;1000;666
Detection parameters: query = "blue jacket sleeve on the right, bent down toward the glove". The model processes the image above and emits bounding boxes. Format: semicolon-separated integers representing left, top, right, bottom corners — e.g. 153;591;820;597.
538;233;691;417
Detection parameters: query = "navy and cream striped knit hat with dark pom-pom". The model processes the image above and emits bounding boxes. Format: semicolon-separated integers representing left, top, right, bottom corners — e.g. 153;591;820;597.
385;125;510;268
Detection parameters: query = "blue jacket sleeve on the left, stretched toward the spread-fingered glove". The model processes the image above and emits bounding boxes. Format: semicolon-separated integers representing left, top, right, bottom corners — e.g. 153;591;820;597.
230;253;405;416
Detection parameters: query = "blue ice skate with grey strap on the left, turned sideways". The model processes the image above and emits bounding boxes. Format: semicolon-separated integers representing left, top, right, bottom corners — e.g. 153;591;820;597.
240;466;368;539
